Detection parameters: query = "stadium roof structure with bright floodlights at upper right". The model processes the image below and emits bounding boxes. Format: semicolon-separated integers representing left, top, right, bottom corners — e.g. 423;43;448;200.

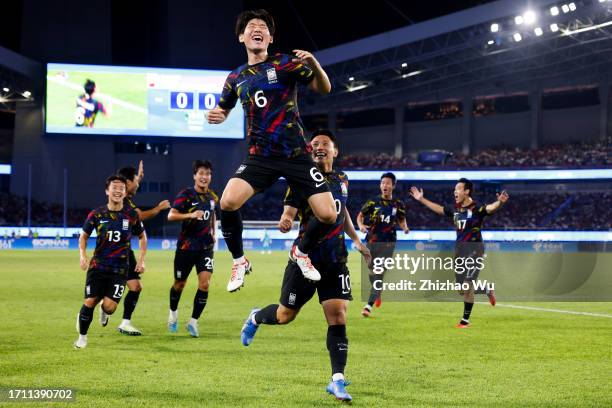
302;0;612;114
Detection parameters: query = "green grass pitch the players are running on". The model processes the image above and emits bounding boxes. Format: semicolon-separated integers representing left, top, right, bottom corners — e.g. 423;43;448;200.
0;250;612;407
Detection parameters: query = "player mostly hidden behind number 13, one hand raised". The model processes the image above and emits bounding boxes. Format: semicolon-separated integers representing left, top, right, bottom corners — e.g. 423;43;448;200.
117;160;170;336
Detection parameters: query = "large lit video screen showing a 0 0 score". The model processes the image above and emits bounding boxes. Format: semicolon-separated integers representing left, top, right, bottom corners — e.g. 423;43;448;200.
45;64;244;139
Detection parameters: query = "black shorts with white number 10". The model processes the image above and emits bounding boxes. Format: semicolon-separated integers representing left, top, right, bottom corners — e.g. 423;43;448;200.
280;261;353;309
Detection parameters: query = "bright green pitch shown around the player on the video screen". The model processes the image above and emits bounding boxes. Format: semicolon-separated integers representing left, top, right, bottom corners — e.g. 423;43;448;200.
45;70;147;129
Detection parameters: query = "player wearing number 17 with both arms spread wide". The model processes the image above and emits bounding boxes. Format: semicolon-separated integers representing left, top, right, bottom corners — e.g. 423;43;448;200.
410;178;510;329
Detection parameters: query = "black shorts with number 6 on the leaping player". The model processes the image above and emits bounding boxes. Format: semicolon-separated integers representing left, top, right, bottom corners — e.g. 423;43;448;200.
232;154;329;198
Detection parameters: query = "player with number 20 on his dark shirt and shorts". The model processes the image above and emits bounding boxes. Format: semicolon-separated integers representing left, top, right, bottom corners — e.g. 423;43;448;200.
168;160;219;337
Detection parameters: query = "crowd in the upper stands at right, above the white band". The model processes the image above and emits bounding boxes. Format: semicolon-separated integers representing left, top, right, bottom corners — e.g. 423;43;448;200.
337;139;612;170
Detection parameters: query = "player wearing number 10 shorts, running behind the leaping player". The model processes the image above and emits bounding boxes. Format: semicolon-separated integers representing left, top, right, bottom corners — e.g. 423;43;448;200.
241;129;371;401
